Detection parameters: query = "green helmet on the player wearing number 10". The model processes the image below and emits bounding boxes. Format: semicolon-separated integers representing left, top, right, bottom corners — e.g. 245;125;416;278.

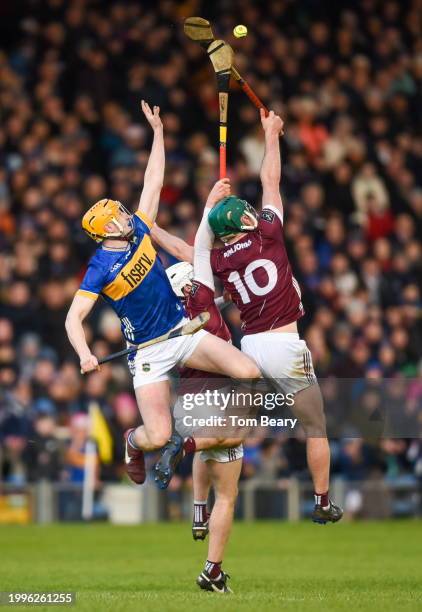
208;196;258;238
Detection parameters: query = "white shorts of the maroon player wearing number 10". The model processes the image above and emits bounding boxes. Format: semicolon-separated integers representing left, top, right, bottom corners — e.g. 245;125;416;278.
241;332;316;393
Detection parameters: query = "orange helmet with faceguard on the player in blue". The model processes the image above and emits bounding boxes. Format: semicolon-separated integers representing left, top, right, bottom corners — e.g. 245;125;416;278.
82;198;134;242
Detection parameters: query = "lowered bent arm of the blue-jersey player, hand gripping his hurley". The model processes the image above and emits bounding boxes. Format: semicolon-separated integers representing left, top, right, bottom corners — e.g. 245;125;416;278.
65;294;99;373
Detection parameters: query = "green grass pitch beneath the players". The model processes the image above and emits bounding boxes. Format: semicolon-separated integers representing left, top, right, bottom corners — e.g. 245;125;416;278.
0;521;422;612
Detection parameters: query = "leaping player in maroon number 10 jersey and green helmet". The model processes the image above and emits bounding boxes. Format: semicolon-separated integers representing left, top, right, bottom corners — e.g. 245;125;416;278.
194;110;343;524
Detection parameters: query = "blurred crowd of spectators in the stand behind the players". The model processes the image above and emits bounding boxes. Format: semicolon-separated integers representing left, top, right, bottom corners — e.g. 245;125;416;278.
0;0;422;522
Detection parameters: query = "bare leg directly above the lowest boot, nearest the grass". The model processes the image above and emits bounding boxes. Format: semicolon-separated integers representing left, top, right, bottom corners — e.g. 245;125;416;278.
207;459;242;563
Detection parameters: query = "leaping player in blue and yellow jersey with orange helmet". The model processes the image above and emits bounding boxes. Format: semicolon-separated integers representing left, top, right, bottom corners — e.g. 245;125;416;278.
66;101;260;484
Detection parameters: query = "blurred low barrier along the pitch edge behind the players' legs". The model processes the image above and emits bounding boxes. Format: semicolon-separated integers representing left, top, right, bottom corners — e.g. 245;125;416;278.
0;478;422;524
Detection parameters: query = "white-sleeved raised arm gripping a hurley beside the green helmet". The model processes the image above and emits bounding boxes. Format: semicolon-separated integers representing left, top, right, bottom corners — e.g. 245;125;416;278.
193;178;230;291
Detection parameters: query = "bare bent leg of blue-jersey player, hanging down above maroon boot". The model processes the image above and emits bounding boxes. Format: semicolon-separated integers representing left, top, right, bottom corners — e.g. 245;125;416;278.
134;381;172;451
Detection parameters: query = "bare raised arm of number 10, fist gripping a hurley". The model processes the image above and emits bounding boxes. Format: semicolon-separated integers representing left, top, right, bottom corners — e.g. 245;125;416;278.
260;109;283;214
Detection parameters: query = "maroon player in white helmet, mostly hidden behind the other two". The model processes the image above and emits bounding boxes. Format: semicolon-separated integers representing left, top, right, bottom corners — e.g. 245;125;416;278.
151;181;247;592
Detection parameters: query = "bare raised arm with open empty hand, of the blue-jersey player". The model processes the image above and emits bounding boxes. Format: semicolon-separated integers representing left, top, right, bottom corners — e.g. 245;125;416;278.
139;100;165;221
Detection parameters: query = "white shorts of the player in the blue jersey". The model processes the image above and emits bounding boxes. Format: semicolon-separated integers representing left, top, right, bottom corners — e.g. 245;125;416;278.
128;318;208;389
